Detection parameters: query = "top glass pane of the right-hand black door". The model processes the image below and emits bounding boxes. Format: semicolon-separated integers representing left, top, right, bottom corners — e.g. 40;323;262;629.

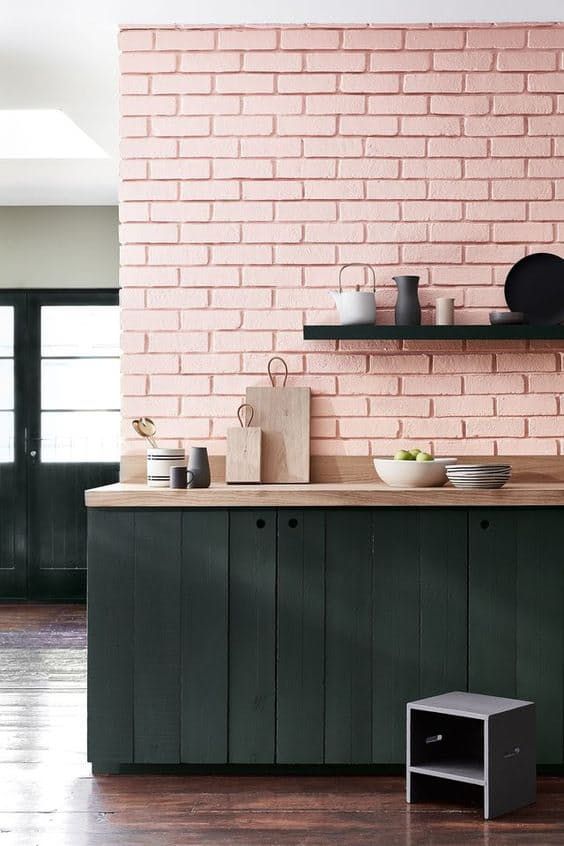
41;306;119;357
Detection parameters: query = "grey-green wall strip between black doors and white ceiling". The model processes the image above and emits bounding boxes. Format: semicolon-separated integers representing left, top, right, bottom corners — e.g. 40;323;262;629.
0;206;119;288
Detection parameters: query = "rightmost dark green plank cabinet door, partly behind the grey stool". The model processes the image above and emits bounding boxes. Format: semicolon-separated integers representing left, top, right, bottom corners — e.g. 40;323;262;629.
468;508;564;764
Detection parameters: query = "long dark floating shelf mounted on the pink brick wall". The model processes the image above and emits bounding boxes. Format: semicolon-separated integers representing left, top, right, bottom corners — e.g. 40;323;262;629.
304;324;564;341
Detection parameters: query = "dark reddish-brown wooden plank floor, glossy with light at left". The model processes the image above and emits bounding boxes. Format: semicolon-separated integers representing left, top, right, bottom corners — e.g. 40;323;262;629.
0;605;564;846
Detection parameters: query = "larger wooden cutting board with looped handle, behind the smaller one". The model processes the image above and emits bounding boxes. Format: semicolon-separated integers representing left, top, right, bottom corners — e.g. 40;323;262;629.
246;356;311;484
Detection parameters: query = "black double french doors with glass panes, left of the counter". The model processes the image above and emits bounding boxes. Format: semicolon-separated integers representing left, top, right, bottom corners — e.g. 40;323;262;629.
0;290;120;599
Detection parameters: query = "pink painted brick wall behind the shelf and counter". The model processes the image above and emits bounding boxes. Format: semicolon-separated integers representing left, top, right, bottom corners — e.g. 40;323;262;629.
120;25;564;455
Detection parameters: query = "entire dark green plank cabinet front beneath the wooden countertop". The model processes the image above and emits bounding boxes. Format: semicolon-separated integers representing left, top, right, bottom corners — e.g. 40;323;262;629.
88;507;564;772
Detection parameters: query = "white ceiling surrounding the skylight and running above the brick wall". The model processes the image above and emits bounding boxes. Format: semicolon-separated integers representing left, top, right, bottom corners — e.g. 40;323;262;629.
0;0;563;205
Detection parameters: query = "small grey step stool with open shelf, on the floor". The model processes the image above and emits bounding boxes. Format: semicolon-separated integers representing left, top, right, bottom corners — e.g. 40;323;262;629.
406;691;536;820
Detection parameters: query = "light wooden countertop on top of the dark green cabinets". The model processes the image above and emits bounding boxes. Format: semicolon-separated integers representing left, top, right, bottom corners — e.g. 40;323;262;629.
85;481;564;508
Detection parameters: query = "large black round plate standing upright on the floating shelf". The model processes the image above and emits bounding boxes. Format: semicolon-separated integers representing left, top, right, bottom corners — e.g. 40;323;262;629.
505;253;564;325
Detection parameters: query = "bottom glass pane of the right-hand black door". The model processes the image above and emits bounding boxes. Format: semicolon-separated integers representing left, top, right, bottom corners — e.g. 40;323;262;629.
41;411;120;462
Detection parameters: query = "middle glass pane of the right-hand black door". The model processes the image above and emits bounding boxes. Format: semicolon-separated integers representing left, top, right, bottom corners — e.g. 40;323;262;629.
42;358;120;410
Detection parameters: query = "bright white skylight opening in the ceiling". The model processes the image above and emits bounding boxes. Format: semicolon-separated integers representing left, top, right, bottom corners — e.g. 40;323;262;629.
0;109;108;159
